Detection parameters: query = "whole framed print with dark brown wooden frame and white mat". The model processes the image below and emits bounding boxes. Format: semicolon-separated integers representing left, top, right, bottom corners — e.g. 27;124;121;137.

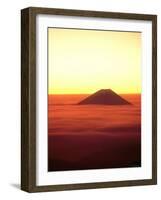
21;7;157;192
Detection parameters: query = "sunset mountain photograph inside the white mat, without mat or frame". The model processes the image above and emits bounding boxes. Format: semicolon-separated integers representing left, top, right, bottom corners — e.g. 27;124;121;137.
47;27;142;172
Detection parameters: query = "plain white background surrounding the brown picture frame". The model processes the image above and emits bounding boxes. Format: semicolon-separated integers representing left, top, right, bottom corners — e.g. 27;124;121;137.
0;0;161;200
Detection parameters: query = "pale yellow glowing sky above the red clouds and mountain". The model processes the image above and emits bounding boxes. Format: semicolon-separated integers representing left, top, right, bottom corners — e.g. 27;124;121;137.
48;28;141;94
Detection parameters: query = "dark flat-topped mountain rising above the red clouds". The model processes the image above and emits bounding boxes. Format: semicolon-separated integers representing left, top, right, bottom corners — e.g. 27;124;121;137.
78;89;131;105
